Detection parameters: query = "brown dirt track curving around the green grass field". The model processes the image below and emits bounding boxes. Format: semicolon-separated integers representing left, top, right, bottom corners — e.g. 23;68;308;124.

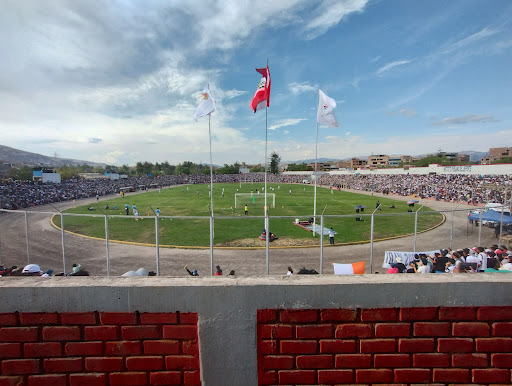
0;185;498;276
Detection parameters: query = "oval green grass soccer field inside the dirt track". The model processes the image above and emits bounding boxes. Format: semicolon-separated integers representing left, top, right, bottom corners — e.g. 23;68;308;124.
54;183;442;247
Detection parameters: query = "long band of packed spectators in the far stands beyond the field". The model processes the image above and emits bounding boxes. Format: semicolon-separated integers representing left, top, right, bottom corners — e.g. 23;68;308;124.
0;173;512;209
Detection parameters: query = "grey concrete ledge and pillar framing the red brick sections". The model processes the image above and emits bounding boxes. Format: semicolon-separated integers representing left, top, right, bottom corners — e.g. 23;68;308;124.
0;274;512;385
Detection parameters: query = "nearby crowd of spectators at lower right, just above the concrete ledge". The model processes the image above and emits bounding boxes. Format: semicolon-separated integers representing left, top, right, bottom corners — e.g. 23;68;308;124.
387;245;512;274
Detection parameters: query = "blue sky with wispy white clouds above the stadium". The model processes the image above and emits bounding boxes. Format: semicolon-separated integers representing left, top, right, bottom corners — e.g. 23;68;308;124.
0;0;512;166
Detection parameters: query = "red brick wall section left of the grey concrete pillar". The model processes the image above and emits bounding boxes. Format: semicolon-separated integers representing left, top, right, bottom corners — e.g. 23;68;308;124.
0;312;201;386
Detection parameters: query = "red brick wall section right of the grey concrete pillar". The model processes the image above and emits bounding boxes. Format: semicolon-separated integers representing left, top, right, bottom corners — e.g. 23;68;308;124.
258;307;512;385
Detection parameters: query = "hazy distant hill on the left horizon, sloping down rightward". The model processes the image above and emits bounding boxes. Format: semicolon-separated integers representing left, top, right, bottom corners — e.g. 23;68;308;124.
0;145;106;167
